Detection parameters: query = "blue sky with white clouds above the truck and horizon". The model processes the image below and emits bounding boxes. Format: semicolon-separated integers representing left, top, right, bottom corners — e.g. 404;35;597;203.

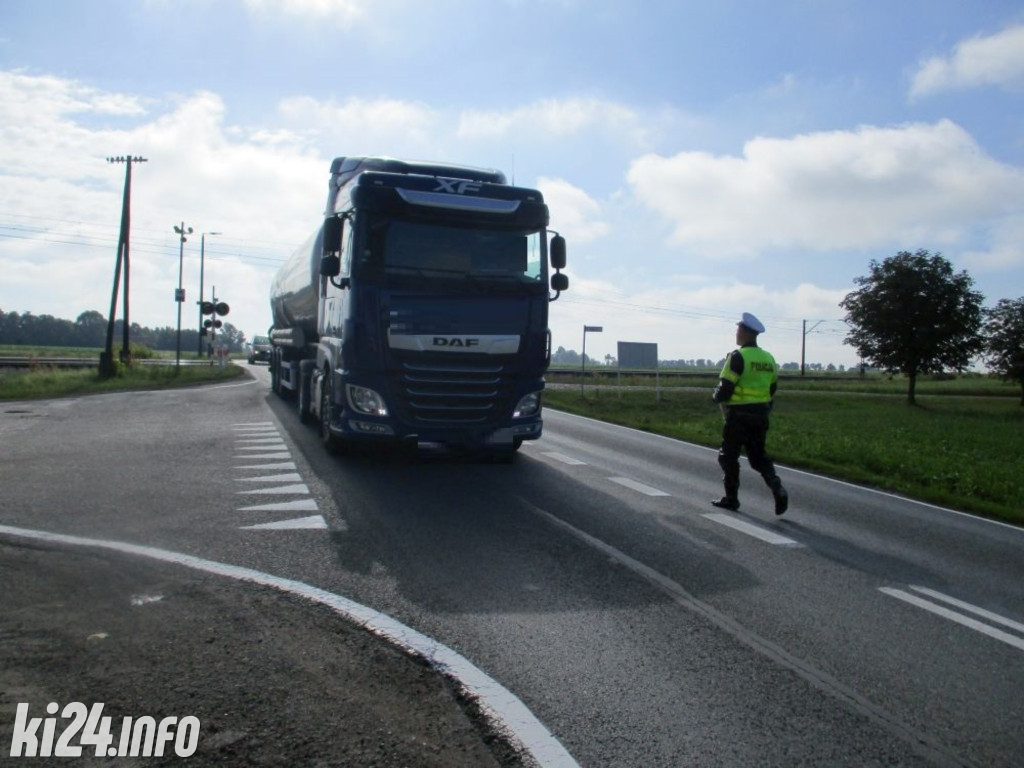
0;0;1024;366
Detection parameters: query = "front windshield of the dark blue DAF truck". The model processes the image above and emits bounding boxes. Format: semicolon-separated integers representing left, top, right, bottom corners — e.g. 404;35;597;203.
372;221;544;291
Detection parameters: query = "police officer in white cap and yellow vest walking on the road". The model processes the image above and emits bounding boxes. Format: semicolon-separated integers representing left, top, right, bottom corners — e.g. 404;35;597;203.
712;312;790;515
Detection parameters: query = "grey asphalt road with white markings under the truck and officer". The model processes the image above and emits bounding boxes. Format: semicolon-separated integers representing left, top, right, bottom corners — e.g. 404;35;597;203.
0;369;1024;768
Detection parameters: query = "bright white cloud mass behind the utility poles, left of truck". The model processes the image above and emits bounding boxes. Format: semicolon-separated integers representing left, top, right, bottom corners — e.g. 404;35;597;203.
0;73;329;334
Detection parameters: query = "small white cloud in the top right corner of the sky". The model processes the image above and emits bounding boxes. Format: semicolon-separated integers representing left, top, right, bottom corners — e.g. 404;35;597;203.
910;26;1024;97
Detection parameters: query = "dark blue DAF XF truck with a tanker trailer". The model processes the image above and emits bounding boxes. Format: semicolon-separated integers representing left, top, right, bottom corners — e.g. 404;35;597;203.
268;157;568;460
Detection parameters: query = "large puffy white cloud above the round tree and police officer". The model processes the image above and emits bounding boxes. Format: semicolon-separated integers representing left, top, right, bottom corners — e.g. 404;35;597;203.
628;120;1024;257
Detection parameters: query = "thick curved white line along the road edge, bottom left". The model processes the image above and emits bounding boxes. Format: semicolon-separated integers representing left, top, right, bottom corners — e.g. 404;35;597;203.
0;525;580;768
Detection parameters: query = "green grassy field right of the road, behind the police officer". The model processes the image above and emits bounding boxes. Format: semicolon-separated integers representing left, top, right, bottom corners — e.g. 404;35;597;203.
545;376;1024;524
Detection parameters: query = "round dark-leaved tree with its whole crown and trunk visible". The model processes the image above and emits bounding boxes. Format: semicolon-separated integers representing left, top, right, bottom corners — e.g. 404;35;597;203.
840;250;984;406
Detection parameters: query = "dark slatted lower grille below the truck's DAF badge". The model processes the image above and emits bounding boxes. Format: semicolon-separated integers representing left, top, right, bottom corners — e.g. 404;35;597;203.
399;362;504;424
